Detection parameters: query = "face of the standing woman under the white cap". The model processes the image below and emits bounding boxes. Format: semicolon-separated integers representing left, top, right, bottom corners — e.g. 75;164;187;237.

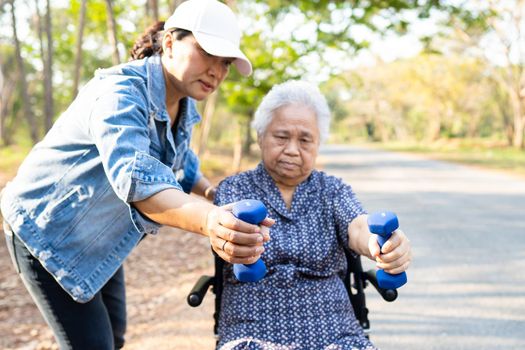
162;33;234;101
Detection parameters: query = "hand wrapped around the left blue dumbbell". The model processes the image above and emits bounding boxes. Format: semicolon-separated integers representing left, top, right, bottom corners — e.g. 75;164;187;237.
207;204;275;264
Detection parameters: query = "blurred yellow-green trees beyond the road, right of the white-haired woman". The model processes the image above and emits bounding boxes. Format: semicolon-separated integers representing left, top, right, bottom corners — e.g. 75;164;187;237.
325;55;509;142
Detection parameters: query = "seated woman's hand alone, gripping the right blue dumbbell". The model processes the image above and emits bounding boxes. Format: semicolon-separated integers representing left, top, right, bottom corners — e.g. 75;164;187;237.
368;229;412;274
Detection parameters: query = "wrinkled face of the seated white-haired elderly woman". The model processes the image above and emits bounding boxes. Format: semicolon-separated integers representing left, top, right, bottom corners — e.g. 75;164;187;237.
258;104;319;185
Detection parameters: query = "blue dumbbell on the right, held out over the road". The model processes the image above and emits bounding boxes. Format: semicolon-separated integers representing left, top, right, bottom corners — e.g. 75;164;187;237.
368;211;407;289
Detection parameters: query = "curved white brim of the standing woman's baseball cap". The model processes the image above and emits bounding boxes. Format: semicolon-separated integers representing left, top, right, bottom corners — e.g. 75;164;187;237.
193;32;252;76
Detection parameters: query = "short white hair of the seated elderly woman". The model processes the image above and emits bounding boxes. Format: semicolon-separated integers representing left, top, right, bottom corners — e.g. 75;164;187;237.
252;80;330;142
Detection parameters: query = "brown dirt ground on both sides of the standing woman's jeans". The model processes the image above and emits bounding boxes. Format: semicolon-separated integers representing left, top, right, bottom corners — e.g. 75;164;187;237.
0;223;214;350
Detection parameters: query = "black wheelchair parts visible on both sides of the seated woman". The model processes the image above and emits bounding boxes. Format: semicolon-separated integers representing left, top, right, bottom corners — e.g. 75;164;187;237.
187;249;398;338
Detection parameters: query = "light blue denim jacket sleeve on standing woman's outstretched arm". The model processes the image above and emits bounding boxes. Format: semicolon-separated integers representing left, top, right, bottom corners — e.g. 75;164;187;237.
89;85;182;203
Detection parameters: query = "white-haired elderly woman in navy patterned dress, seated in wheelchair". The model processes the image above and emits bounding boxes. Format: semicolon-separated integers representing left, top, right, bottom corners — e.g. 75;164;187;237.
215;81;411;350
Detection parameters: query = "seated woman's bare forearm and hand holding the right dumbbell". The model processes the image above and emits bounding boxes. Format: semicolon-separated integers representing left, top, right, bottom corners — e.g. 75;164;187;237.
348;214;412;274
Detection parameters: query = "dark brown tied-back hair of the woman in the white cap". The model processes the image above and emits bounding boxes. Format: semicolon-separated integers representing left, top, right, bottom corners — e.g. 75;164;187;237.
129;21;191;61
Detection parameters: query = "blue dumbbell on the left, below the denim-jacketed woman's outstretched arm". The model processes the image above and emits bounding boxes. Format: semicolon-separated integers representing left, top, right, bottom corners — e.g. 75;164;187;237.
232;199;268;282
